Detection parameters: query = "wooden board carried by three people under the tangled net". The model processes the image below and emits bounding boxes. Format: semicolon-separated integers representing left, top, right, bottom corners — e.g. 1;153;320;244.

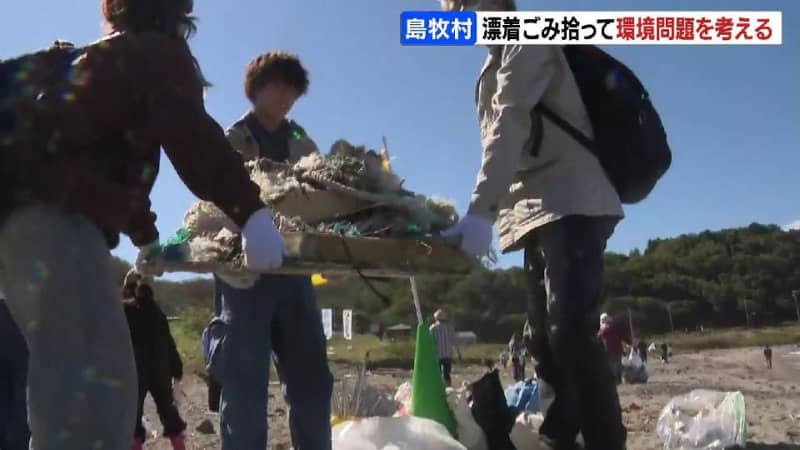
166;232;475;278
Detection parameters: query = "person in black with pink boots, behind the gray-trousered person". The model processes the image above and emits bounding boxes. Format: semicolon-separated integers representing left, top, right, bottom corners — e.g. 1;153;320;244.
122;270;186;450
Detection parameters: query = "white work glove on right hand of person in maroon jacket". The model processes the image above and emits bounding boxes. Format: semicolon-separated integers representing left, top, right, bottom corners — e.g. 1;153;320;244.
242;208;285;273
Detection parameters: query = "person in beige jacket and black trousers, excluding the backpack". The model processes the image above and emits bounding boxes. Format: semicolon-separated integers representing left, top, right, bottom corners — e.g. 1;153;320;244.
442;0;626;450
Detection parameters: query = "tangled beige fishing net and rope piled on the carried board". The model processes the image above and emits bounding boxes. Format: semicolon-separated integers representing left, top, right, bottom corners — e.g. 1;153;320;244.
159;140;458;269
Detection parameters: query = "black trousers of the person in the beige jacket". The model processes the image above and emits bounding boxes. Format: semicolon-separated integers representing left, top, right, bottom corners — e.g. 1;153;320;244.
525;216;627;450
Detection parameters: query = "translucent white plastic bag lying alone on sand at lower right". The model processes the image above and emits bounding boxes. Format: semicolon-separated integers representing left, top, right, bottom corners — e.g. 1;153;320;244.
656;389;747;450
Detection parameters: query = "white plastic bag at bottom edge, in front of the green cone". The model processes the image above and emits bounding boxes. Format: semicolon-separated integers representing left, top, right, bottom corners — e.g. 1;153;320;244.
332;416;467;450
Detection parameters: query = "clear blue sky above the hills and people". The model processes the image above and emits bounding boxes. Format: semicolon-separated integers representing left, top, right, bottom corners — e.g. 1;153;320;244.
0;0;800;278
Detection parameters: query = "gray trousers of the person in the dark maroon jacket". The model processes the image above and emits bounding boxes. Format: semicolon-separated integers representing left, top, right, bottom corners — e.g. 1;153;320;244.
0;206;137;450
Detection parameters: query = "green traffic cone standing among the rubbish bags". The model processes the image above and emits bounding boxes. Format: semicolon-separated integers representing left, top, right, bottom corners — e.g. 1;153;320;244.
411;323;456;437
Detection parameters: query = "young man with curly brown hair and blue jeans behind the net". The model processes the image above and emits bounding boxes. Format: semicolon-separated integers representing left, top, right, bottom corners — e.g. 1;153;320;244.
211;52;333;450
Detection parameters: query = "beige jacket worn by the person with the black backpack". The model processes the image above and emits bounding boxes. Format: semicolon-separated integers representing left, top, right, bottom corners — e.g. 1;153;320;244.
469;45;624;252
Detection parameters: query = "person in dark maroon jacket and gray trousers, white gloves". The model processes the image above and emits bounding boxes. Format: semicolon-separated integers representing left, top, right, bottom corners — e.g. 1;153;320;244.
0;0;284;450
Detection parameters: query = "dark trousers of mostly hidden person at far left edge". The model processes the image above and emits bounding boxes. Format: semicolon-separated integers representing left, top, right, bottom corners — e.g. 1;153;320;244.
0;292;31;450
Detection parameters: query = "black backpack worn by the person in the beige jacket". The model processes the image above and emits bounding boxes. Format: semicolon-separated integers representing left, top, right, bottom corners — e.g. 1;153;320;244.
534;45;672;204
